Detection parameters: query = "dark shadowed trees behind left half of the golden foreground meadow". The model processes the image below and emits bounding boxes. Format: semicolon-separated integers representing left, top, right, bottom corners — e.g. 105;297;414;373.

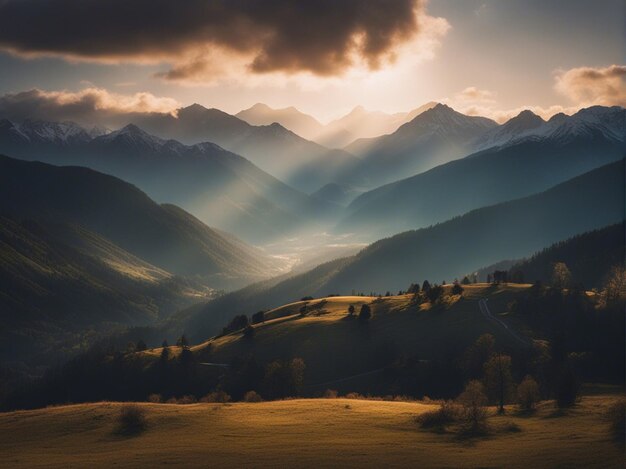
0;336;306;409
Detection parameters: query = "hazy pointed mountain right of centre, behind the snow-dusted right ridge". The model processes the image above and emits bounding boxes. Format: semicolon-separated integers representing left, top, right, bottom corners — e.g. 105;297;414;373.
345;104;497;187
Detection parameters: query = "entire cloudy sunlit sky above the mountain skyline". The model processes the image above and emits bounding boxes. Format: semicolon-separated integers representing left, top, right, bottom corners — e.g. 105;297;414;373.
0;0;626;122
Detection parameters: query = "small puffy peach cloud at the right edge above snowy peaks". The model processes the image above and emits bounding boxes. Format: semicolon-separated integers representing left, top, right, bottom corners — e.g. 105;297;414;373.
555;65;626;106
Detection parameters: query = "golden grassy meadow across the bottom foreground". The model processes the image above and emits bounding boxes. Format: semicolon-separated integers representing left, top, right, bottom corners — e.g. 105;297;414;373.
0;396;624;468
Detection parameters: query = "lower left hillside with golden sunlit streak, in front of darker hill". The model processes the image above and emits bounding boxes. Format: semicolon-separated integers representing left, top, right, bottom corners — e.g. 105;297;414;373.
0;212;202;366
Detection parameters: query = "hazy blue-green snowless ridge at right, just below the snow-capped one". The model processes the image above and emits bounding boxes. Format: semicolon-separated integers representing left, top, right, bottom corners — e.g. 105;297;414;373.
324;160;626;292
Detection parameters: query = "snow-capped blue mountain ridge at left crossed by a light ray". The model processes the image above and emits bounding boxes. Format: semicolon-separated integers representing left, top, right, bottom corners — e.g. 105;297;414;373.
0;121;336;242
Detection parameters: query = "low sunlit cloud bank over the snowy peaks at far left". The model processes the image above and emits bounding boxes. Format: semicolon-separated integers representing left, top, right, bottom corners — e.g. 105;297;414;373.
0;88;180;125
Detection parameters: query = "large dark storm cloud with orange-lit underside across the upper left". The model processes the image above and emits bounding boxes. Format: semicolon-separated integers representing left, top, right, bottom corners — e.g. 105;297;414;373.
0;0;425;78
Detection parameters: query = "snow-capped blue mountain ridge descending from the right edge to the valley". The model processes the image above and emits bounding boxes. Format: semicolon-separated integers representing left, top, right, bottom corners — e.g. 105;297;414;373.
338;108;626;236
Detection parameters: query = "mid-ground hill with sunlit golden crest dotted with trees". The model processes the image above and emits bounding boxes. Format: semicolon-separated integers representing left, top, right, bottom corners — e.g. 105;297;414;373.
184;284;529;388
